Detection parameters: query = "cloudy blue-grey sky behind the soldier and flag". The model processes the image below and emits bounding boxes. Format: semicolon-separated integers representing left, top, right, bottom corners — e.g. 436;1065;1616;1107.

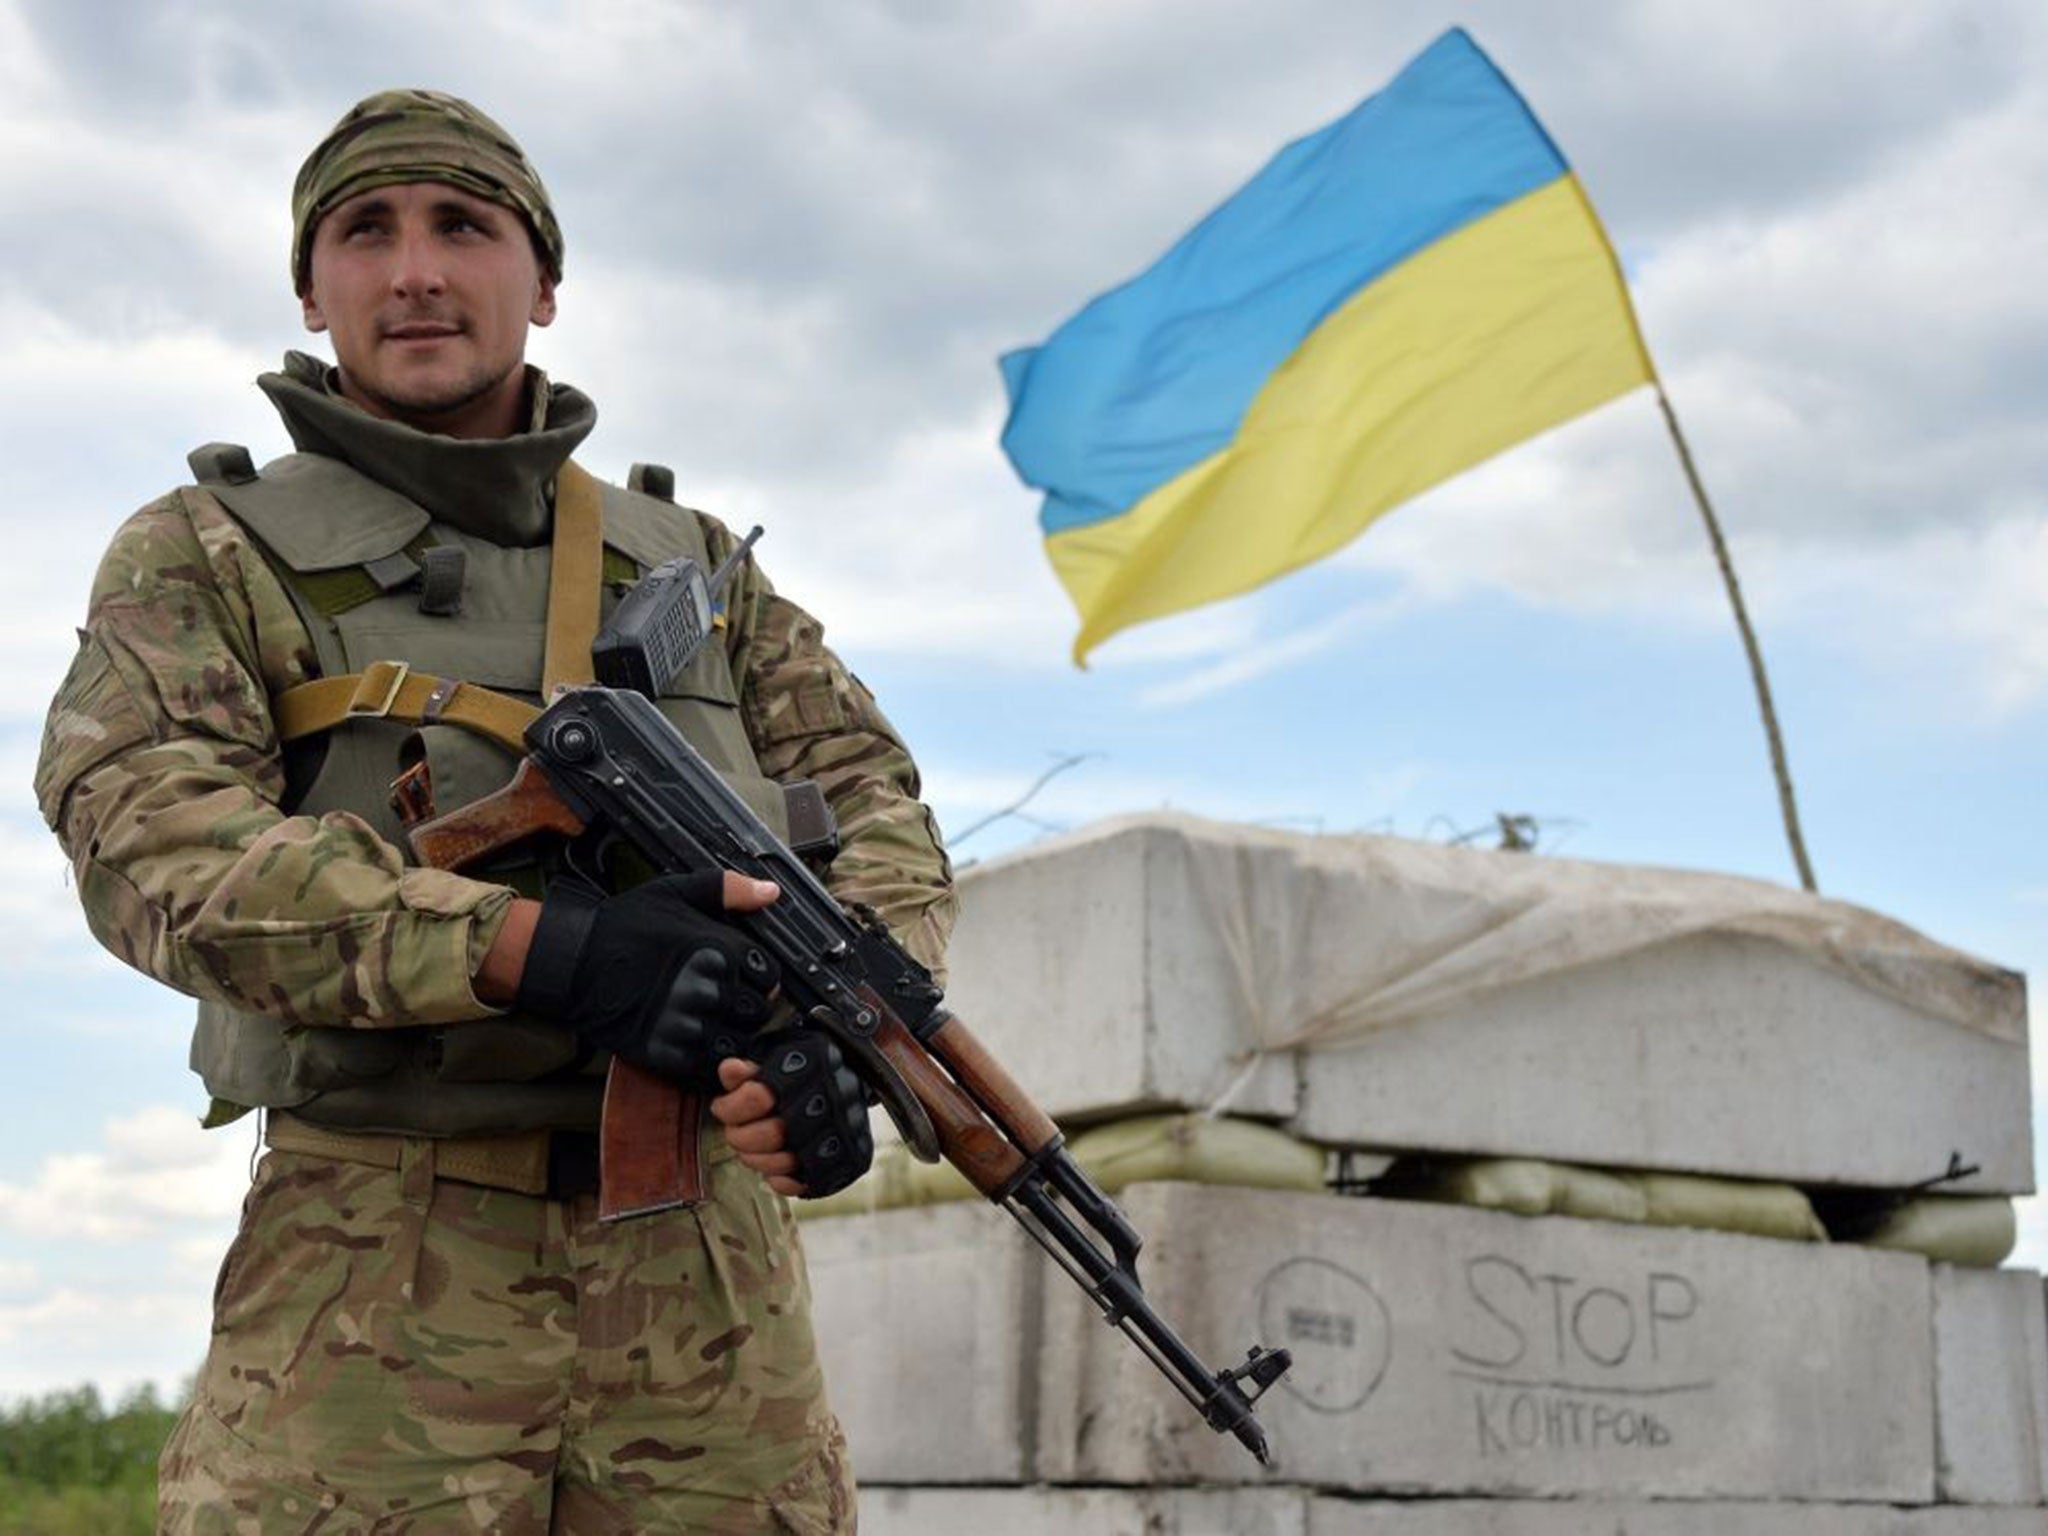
0;0;2048;1399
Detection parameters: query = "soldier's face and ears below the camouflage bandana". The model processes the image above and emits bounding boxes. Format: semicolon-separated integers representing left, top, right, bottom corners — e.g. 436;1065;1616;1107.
301;182;555;438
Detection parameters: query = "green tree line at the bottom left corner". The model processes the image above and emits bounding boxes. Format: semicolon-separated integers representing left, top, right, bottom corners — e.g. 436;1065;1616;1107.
0;1386;180;1536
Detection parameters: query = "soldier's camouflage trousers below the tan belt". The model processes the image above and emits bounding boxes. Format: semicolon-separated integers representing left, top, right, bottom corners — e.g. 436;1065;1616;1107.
158;1137;854;1536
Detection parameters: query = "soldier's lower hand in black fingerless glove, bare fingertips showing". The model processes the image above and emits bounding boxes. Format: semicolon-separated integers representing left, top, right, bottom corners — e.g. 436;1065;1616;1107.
711;1028;874;1198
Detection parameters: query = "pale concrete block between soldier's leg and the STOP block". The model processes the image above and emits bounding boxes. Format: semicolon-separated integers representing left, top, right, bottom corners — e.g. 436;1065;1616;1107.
803;1202;1032;1483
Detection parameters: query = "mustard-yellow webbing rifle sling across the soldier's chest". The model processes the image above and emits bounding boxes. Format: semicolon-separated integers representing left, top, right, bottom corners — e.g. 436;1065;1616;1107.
270;461;604;752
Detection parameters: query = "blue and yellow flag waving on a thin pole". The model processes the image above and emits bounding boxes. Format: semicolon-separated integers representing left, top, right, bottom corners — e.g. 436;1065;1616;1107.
1001;29;1653;662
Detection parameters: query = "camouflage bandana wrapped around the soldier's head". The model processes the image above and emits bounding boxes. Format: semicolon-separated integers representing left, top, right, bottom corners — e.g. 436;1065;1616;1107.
291;90;561;295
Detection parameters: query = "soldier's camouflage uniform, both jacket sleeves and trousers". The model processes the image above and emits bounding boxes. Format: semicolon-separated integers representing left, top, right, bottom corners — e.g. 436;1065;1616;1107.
37;346;952;1534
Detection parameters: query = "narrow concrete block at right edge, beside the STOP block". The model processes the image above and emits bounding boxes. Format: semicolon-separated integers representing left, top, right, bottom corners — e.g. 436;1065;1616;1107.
1933;1264;2048;1507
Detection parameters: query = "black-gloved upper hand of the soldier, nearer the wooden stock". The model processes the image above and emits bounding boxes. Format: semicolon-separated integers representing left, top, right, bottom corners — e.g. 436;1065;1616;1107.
518;870;782;1094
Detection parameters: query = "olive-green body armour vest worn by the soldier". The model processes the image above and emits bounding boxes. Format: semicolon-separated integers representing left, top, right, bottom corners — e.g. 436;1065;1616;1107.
193;453;786;1137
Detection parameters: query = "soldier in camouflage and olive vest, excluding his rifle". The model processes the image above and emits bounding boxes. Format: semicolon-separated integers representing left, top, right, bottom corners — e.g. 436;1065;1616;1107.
37;90;952;1534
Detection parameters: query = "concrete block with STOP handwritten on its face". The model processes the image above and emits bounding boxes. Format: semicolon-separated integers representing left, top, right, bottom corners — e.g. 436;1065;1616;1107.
1036;1184;1933;1503
